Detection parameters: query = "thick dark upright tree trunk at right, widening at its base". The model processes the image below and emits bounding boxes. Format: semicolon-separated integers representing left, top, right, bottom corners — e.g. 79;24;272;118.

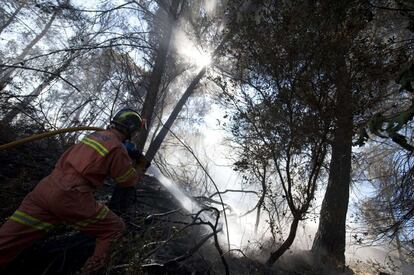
312;52;353;267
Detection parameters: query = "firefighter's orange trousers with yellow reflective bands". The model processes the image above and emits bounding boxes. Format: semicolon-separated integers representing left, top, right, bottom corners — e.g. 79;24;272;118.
0;180;125;266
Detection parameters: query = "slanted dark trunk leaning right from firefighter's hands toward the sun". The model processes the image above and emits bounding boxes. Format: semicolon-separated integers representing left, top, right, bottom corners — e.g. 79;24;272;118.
145;67;207;162
